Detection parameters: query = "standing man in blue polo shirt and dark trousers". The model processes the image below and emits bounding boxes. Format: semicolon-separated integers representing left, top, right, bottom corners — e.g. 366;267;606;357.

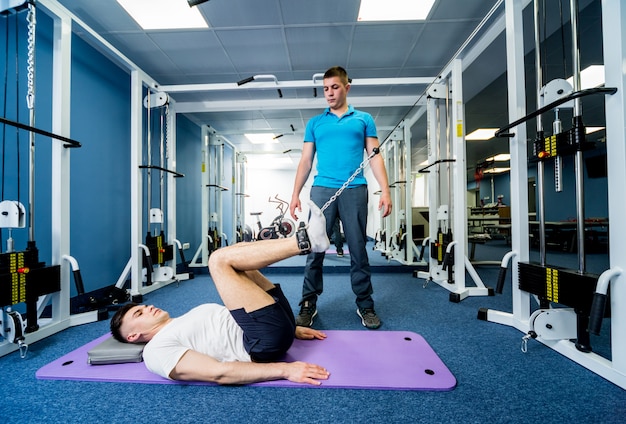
289;66;391;329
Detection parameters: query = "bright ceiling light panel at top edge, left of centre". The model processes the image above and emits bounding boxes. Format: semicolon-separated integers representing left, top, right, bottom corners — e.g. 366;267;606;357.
117;0;209;30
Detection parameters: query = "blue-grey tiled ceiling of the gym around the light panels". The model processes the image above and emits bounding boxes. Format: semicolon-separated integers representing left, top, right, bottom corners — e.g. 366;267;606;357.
46;0;601;176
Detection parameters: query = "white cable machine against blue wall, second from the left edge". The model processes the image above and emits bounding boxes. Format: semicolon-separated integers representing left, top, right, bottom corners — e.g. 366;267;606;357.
115;83;193;302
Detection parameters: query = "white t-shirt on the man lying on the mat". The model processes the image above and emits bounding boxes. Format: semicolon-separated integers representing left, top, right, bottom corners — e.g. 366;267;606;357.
143;303;251;379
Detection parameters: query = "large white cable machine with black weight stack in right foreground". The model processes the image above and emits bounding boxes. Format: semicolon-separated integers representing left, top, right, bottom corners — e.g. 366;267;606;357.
478;0;626;388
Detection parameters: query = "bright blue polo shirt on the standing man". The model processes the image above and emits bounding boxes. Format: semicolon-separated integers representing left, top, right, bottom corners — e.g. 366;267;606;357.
304;105;378;188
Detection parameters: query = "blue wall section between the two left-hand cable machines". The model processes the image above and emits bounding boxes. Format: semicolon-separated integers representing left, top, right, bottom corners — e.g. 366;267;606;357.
70;30;131;291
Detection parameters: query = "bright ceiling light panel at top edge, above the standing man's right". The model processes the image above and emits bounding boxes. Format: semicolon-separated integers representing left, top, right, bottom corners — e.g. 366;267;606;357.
357;0;435;22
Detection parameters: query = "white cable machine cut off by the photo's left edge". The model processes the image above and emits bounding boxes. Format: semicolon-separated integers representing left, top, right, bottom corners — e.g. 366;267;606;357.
0;1;108;357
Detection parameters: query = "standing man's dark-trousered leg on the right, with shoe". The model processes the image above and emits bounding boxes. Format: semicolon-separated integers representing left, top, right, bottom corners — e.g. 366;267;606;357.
337;186;381;329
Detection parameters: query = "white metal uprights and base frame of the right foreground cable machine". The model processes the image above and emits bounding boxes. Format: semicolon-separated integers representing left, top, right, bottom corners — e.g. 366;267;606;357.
479;0;626;389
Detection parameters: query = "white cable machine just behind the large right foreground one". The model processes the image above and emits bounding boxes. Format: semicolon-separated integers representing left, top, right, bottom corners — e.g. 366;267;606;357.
414;59;493;302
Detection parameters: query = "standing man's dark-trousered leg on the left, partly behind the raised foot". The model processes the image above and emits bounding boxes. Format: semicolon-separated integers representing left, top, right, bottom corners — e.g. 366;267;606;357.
296;187;337;327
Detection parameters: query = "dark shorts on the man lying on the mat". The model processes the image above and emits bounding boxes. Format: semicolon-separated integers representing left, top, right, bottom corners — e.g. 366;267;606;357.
230;302;296;362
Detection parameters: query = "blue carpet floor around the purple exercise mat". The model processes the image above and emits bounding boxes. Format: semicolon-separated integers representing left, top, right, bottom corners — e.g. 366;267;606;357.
0;240;626;424
